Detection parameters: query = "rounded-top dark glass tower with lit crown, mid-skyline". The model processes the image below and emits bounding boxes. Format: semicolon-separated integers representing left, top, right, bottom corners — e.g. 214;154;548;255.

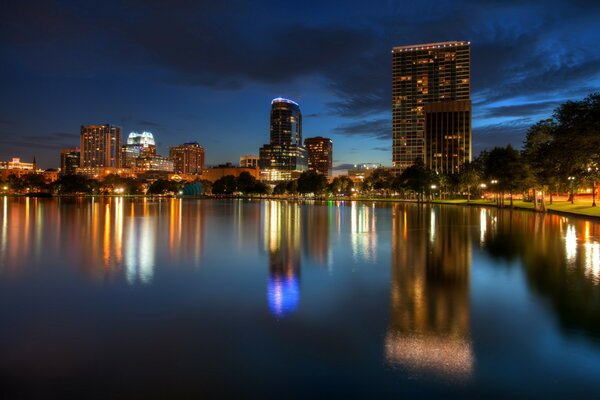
258;97;307;181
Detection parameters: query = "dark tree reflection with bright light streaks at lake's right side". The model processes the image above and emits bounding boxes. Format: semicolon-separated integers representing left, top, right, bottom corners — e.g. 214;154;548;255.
485;210;600;342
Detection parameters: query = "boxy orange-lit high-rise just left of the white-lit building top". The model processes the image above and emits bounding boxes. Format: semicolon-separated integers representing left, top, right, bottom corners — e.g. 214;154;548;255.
80;124;121;168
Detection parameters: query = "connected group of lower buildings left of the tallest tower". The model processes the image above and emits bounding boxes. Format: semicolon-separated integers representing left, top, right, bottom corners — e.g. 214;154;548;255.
54;98;333;183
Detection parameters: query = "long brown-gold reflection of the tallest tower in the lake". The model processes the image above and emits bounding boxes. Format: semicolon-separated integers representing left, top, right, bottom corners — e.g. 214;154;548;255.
385;204;474;379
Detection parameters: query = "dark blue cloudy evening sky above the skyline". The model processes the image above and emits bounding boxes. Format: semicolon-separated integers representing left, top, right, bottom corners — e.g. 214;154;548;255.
0;0;600;168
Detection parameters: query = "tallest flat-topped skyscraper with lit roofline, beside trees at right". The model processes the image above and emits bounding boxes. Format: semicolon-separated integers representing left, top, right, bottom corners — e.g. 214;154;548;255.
392;42;471;172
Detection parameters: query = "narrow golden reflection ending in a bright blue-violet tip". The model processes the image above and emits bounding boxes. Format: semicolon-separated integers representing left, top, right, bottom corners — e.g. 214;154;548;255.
262;201;301;317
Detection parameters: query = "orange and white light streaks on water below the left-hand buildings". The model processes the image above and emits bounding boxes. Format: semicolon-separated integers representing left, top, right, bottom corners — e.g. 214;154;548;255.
0;197;204;284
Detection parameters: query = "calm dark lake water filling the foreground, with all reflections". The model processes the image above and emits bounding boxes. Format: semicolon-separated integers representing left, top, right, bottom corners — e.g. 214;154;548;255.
0;197;600;399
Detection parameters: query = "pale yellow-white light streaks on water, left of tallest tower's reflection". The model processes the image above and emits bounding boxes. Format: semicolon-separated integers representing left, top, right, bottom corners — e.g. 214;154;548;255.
350;202;377;262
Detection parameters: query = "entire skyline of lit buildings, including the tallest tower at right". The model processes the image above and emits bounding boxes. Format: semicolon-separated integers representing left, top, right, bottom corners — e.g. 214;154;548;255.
0;42;472;184
